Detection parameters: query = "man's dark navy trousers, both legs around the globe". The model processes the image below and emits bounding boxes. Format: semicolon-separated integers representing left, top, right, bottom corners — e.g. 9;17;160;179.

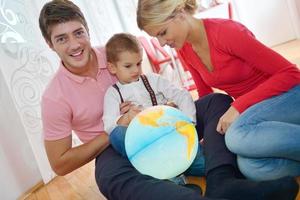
95;94;236;200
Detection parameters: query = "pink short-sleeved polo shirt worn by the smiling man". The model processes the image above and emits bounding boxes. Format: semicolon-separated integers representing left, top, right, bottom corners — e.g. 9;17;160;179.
42;48;116;142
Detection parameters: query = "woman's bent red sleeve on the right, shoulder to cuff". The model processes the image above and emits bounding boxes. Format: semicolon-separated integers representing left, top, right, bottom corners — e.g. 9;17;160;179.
219;21;300;113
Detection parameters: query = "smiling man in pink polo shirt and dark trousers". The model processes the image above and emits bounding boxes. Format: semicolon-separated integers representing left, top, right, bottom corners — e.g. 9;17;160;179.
39;0;298;200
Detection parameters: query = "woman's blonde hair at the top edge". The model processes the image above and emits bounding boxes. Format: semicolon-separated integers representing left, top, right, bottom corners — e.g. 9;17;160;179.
137;0;197;30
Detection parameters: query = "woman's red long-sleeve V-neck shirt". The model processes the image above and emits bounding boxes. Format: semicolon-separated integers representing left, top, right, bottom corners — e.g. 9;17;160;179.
179;19;300;113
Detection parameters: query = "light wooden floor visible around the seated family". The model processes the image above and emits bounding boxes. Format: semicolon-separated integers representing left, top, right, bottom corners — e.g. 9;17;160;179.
19;40;300;200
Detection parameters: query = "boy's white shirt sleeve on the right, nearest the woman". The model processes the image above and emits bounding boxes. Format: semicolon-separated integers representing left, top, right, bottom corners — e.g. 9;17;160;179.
147;74;196;122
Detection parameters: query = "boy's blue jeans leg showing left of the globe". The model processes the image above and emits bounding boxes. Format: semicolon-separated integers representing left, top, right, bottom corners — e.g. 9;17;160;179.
109;126;127;158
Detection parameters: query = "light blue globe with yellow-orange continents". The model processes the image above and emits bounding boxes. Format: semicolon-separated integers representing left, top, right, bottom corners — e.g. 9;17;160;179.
125;105;198;179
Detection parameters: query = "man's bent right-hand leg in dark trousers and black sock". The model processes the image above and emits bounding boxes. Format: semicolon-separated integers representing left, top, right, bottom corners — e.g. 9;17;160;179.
196;94;298;200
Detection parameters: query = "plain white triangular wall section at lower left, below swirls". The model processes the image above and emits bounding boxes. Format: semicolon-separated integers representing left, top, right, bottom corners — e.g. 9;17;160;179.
0;70;42;200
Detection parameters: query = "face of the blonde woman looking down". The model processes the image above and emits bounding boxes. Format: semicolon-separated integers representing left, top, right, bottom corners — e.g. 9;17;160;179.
144;13;188;49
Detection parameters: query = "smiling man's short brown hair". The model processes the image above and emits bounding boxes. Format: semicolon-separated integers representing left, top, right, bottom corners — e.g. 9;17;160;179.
39;0;89;43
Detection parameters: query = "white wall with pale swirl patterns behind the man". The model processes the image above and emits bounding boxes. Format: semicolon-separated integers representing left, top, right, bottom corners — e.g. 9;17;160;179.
0;0;141;200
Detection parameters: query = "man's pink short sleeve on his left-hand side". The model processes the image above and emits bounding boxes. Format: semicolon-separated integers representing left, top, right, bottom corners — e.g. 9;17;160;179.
41;97;72;140
